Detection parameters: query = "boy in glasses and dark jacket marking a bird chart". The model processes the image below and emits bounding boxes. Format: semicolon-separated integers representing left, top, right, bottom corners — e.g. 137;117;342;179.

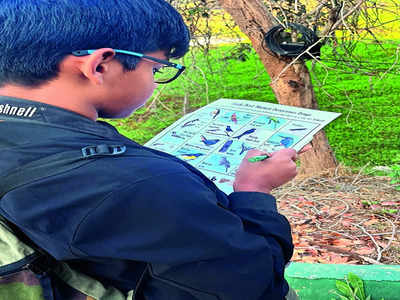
0;0;296;300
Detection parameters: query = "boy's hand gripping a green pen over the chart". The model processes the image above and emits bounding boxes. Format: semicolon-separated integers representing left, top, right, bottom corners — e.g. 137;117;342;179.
233;148;297;193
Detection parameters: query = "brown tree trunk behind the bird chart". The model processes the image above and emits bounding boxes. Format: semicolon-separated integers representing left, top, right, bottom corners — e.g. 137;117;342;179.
219;0;337;175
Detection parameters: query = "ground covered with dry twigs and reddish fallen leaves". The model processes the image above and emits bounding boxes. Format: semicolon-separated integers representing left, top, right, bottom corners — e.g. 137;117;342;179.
274;167;400;264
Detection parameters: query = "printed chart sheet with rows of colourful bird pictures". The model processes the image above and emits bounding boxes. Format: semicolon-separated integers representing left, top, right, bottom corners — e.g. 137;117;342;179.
145;99;340;194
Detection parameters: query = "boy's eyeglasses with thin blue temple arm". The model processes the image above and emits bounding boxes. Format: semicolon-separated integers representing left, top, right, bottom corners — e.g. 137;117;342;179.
72;49;185;84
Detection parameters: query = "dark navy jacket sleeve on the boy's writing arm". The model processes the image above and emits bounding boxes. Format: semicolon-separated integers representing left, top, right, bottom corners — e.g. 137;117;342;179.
72;170;293;300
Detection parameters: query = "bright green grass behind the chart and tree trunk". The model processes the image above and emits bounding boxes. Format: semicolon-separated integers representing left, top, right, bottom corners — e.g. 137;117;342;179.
106;43;400;167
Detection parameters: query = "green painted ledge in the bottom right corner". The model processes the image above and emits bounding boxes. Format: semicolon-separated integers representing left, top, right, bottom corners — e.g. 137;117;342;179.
285;263;400;300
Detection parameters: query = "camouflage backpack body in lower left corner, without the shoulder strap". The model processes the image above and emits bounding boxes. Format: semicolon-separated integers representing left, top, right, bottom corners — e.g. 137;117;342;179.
0;218;133;300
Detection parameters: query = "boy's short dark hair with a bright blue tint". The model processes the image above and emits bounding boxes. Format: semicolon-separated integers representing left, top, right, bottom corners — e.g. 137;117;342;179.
0;0;189;87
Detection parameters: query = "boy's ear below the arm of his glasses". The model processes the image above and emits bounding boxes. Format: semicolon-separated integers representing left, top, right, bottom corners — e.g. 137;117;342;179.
80;48;115;85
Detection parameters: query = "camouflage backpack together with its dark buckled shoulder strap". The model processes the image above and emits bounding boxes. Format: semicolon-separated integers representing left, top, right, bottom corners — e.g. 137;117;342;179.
0;144;143;300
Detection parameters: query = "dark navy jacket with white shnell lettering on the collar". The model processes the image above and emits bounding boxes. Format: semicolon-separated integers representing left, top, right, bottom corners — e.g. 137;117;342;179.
0;97;293;300
